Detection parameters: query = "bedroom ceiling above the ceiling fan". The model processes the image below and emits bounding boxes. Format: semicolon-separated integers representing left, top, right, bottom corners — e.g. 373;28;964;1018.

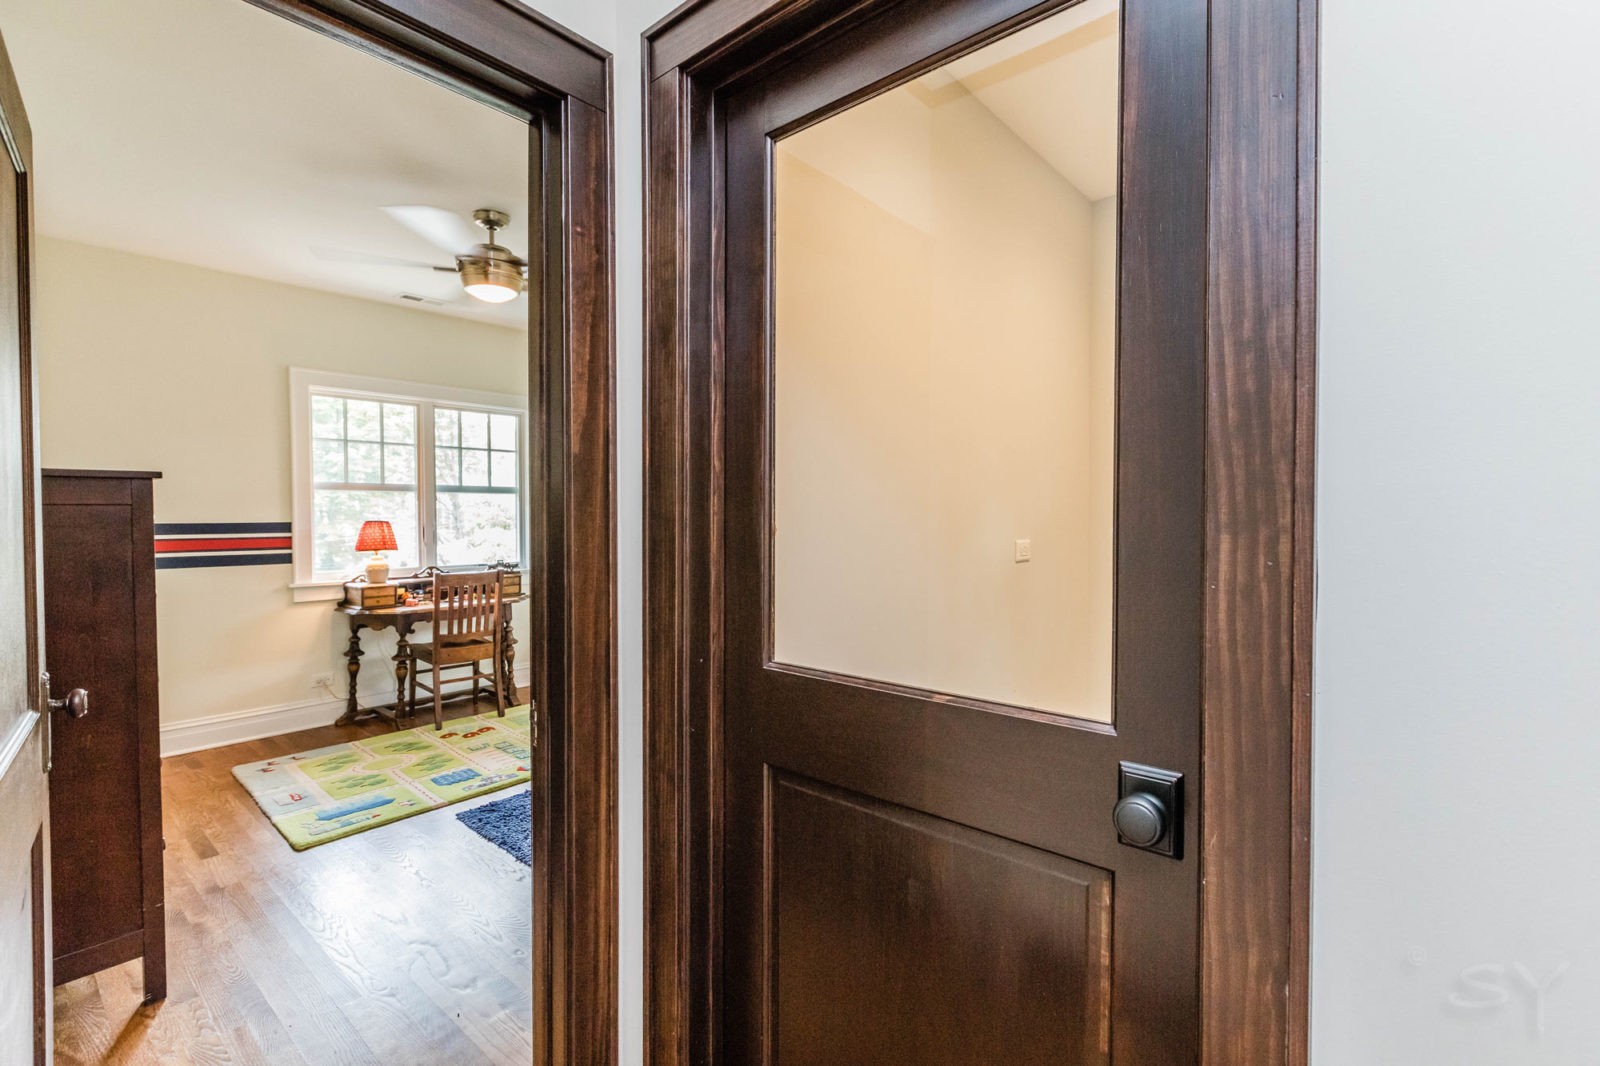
0;0;528;328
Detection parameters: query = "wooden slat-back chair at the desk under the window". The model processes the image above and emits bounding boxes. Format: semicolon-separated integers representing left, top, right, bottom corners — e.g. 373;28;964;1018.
411;570;506;730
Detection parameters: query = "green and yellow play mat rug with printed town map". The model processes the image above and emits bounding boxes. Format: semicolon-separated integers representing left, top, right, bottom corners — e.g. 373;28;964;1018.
234;706;531;852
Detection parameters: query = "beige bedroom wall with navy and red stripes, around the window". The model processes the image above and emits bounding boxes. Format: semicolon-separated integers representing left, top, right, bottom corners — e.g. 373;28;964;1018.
35;238;526;739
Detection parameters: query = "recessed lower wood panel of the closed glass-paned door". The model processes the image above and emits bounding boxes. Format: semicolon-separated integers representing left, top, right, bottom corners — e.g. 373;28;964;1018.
766;773;1112;1066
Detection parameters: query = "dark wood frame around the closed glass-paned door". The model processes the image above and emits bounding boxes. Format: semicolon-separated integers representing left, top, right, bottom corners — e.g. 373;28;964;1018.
643;0;1317;1066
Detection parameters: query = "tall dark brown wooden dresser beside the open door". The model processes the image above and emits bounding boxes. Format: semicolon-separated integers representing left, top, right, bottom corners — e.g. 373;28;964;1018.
42;471;166;1002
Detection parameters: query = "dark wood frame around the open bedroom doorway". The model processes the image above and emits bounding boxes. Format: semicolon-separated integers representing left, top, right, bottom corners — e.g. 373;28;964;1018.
236;0;618;1066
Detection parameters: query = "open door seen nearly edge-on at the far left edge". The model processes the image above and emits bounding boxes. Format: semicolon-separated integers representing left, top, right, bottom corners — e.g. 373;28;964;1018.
0;24;50;1066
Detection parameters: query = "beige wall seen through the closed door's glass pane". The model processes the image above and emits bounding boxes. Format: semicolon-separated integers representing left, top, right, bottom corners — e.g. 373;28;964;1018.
774;88;1115;719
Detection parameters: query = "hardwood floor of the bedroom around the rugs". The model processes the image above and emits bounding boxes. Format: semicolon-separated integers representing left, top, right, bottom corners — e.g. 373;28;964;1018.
56;703;538;1066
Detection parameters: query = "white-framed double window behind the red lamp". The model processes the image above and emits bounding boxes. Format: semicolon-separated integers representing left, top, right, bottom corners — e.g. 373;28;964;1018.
290;370;526;599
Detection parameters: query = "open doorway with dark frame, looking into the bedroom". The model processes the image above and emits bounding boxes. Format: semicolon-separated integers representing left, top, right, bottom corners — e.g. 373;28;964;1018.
0;0;616;1063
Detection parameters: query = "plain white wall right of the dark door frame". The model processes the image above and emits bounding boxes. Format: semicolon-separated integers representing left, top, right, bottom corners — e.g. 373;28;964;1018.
1312;0;1600;1066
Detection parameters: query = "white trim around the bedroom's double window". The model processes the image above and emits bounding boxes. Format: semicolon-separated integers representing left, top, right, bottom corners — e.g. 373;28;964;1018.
290;367;528;603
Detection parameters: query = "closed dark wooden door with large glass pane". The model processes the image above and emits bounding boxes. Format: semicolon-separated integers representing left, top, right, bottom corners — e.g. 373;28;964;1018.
715;0;1206;1066
